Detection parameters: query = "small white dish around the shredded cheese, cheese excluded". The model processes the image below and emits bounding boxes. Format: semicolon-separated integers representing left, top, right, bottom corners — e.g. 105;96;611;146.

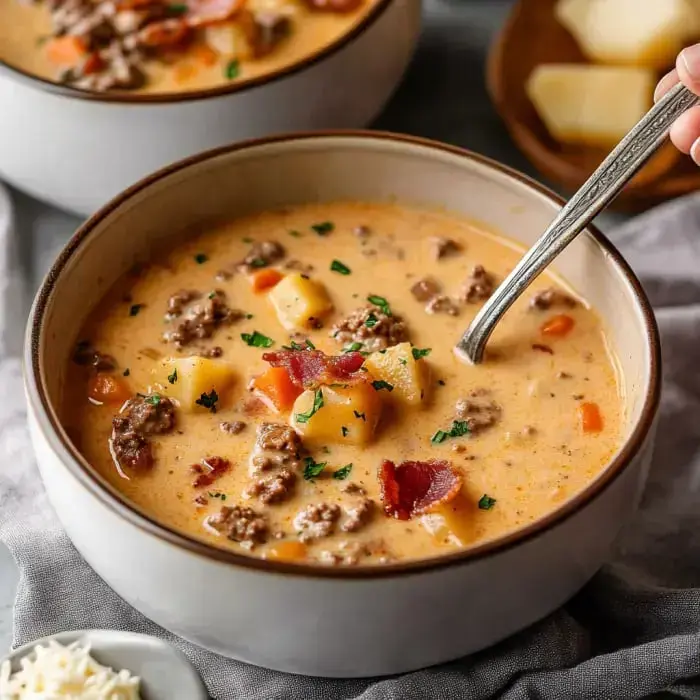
0;630;209;700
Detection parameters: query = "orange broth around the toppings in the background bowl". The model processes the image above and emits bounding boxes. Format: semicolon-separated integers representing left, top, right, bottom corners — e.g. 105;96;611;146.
0;0;378;93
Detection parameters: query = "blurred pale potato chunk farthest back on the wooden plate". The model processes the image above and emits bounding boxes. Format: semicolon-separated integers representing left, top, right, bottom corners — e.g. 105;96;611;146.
555;0;698;69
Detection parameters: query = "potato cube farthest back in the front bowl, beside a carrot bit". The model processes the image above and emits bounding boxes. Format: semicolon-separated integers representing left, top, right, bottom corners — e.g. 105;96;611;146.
268;273;333;331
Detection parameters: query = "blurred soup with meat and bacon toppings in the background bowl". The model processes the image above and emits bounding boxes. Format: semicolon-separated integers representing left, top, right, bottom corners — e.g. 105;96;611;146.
0;0;377;93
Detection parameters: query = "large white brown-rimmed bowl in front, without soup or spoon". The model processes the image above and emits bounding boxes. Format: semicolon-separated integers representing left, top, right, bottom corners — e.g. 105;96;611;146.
25;132;661;676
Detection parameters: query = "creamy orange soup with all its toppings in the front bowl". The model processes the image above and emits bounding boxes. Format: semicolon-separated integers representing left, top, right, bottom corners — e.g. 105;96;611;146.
62;203;623;565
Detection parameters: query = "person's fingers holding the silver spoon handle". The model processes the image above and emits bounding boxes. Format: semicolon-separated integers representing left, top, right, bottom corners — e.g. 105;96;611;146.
654;44;700;165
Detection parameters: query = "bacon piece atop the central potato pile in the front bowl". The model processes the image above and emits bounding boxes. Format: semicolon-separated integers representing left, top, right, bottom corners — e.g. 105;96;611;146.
263;350;365;388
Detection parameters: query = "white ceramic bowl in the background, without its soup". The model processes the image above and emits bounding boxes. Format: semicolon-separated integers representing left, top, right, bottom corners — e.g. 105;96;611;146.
0;0;421;216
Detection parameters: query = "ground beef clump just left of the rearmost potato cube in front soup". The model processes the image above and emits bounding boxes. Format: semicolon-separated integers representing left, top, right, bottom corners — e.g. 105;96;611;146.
163;290;245;349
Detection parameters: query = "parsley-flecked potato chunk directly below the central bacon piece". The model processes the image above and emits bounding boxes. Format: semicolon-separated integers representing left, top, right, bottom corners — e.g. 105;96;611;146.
291;381;382;446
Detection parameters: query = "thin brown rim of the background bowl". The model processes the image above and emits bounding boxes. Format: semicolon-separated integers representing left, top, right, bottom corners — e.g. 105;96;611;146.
0;0;394;105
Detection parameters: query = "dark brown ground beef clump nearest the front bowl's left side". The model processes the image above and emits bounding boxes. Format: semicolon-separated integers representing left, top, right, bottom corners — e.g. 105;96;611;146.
110;394;175;469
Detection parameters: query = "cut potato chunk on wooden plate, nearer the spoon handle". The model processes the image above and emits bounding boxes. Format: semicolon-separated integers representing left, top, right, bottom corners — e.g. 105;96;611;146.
526;64;656;148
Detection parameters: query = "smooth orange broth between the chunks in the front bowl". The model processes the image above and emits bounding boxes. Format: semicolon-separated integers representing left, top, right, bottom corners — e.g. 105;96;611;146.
62;203;622;562
